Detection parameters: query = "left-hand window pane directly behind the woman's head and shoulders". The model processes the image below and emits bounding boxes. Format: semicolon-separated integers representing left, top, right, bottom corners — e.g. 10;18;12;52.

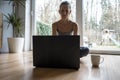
35;0;76;35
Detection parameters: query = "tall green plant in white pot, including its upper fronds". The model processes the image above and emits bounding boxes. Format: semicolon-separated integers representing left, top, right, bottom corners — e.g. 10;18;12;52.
5;0;26;53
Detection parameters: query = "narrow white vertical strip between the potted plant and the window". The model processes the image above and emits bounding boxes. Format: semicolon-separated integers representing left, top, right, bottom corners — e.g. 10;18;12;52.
24;0;32;51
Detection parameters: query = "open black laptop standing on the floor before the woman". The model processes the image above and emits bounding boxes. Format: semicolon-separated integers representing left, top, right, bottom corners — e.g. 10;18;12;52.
33;36;80;69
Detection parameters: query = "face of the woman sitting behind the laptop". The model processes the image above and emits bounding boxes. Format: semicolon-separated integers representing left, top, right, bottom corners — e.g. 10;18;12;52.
59;5;71;19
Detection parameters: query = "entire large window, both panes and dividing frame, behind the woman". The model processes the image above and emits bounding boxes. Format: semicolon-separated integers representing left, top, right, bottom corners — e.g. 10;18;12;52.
32;0;120;53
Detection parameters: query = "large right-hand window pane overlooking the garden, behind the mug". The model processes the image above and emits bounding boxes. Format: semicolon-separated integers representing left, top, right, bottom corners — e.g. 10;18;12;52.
83;0;120;50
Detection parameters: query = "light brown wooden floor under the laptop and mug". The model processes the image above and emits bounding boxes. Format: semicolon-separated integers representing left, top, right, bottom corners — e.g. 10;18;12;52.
0;52;120;80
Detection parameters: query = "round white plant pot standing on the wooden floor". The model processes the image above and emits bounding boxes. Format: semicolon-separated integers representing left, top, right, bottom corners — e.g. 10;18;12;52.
8;38;24;53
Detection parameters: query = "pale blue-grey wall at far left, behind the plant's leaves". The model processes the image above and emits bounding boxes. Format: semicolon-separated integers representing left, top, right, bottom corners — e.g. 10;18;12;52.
0;1;13;52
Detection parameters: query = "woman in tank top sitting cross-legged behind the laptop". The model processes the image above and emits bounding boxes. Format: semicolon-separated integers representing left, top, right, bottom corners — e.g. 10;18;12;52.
52;1;89;57
